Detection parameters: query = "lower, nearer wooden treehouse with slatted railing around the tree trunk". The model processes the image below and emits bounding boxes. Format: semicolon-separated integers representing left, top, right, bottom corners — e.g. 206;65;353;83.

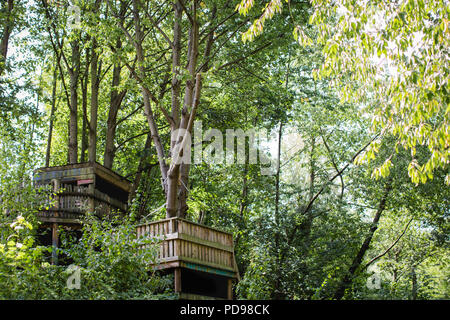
137;218;238;299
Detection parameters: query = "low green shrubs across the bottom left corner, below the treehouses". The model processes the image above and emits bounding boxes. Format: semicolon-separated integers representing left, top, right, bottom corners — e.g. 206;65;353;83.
0;211;175;300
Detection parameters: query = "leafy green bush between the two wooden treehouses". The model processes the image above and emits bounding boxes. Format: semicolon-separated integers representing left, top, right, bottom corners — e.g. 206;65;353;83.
62;215;174;299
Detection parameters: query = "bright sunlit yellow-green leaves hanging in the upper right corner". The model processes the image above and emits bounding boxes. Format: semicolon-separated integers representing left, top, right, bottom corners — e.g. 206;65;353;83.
237;0;450;184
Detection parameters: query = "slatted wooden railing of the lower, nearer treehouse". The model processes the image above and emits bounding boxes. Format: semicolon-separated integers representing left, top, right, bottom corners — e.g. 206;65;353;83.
136;218;236;272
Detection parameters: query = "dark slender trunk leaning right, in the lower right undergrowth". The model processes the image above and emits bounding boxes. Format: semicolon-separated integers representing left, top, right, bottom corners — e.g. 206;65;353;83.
334;180;392;300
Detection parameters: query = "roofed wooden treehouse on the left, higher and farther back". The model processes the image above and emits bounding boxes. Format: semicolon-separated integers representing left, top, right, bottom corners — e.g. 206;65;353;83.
33;162;131;263
